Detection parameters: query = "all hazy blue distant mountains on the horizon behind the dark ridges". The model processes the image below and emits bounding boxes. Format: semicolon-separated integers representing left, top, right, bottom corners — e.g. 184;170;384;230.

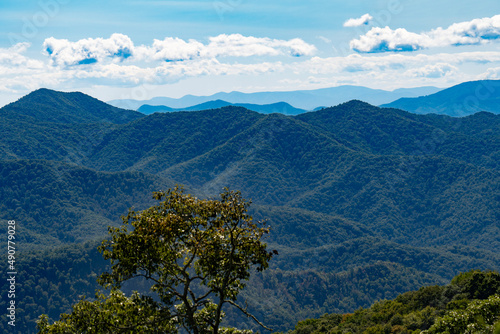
110;80;500;117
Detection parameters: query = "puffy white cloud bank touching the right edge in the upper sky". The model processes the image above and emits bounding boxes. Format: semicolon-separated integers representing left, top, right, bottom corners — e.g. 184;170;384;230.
350;15;500;53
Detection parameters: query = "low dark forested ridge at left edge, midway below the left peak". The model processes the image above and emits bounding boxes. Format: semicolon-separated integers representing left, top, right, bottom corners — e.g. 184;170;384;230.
0;160;174;250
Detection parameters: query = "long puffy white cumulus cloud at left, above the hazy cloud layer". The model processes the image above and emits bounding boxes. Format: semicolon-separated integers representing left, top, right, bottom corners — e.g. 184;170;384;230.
43;34;316;66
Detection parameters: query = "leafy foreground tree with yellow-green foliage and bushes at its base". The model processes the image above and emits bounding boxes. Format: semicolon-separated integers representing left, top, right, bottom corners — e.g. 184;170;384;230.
38;187;275;334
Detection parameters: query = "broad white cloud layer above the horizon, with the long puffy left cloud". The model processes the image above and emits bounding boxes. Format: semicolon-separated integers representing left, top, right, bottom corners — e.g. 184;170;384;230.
0;35;500;101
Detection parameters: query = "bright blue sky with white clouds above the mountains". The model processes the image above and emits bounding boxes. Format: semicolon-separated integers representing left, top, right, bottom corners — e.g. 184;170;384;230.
0;0;500;106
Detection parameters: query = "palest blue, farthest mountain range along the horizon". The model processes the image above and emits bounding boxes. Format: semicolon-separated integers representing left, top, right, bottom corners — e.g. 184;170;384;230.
108;86;440;110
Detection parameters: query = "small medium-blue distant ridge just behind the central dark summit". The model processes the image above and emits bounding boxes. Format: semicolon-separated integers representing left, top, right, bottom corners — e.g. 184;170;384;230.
137;100;306;115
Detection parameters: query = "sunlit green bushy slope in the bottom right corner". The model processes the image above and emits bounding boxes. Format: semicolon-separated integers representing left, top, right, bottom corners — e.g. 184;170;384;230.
289;271;500;334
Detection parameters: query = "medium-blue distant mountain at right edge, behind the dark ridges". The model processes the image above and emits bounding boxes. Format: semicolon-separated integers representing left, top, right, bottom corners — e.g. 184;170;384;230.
382;80;500;116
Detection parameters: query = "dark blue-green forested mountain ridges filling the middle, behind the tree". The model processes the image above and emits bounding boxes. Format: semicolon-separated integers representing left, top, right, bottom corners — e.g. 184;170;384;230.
0;90;500;333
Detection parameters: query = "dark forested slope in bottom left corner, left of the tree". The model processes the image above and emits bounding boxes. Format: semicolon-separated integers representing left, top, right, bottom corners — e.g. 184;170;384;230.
0;241;109;334
